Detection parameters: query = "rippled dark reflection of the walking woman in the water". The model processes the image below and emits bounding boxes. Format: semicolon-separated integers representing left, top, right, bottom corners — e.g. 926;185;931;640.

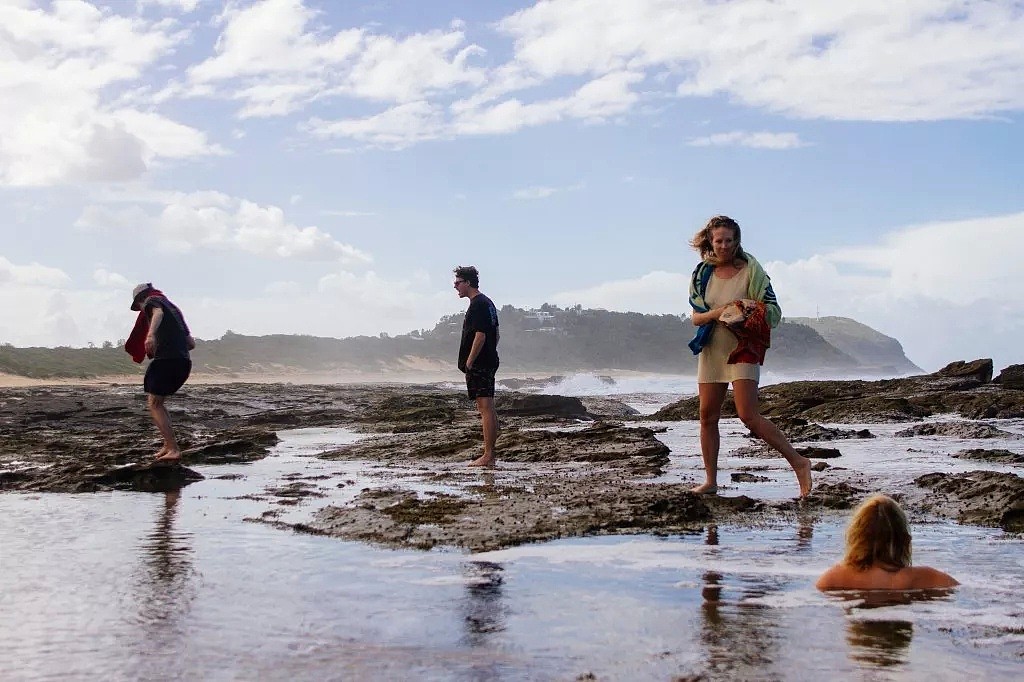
700;526;780;678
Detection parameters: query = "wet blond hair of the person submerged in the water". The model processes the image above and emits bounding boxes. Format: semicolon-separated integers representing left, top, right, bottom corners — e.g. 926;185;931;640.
843;495;911;570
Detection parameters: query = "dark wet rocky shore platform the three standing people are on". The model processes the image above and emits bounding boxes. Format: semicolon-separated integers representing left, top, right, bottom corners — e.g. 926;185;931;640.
0;359;1024;551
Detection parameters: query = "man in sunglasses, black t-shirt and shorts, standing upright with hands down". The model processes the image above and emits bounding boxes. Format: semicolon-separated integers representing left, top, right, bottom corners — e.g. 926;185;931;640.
455;265;499;467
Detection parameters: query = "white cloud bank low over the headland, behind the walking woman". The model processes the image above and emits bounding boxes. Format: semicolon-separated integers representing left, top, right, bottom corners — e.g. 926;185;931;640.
551;213;1024;370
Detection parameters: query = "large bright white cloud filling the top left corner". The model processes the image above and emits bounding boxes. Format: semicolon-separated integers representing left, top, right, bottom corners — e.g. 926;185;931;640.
0;1;222;186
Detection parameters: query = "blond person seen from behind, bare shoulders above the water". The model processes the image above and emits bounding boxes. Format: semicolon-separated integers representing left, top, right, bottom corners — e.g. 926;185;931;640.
814;495;959;590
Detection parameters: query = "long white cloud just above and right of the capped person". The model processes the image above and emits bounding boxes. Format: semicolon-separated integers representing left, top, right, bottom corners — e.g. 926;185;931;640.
75;191;372;264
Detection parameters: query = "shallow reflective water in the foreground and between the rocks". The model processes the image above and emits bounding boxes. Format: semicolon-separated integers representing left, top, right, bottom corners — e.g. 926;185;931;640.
0;422;1024;680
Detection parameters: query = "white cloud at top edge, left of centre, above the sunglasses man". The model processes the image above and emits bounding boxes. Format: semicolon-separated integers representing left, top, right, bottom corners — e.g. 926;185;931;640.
188;0;484;118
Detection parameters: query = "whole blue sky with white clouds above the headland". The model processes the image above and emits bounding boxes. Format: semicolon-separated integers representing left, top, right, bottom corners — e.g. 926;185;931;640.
0;0;1024;372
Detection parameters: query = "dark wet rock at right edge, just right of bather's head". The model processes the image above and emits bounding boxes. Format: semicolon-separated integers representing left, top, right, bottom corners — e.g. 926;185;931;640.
914;471;1024;531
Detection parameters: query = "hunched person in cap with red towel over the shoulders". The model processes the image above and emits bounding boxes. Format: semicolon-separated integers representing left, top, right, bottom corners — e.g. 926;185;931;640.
125;282;196;462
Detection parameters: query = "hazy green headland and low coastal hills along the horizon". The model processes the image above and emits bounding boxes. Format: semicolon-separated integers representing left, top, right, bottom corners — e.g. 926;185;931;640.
0;305;920;378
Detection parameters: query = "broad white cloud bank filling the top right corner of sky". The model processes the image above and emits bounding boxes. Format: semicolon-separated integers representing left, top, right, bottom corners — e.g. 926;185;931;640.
498;0;1024;121
